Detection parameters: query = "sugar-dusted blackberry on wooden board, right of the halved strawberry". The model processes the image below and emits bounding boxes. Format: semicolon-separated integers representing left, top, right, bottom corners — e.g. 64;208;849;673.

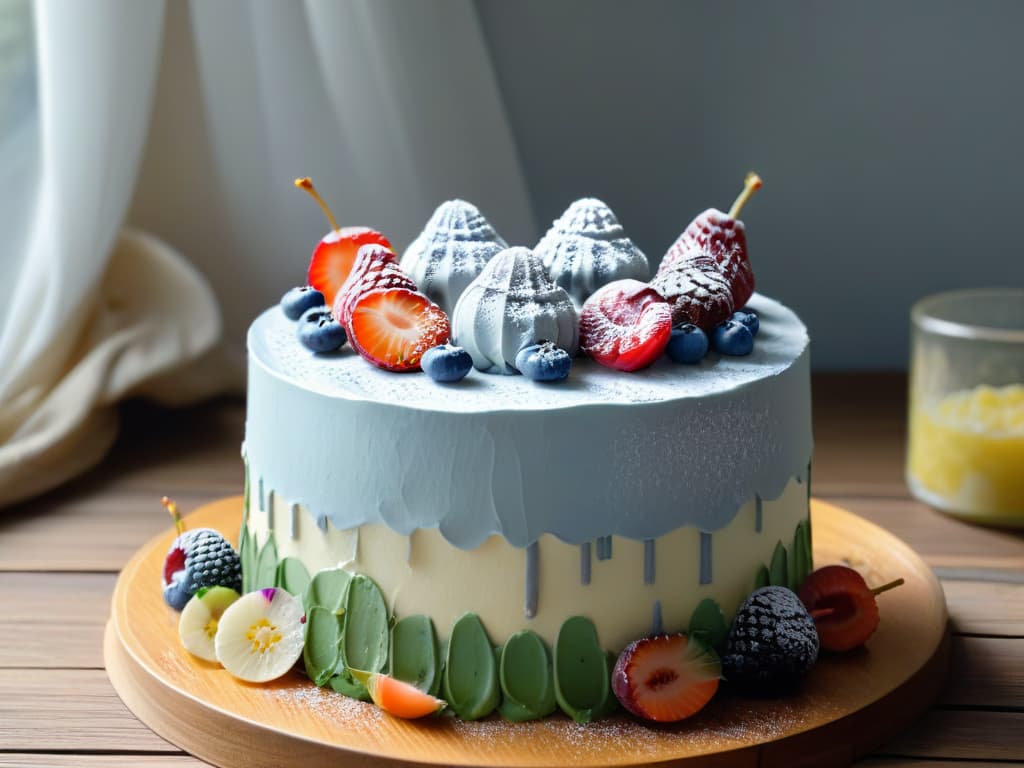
722;587;818;693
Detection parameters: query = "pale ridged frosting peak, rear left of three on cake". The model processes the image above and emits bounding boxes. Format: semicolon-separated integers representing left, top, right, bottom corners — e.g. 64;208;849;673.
401;200;508;316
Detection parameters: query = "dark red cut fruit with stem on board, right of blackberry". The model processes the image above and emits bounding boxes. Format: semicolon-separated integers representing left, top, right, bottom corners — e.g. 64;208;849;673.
799;565;903;651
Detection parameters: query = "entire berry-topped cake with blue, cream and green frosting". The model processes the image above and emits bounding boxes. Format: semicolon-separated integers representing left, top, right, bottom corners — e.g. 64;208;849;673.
165;174;843;722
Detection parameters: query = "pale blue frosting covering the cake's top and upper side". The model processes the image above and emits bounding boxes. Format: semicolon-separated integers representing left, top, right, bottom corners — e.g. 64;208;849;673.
244;295;812;549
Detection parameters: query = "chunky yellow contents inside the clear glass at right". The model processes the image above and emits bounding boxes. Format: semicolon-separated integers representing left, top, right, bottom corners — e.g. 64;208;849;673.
908;384;1024;525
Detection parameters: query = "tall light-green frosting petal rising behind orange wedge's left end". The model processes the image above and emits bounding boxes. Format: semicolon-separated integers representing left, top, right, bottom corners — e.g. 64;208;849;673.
341;573;389;690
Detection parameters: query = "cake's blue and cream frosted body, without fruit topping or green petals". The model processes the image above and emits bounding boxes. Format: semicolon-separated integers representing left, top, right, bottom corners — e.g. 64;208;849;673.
244;296;812;652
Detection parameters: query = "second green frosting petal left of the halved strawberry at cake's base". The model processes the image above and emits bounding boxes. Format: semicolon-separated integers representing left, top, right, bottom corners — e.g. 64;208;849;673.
499;630;558;723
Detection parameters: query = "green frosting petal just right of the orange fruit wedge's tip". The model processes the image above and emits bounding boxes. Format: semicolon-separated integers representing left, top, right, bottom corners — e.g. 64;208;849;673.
442;613;501;720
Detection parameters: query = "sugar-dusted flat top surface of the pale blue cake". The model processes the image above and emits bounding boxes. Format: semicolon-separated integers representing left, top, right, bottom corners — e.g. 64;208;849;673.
249;294;808;413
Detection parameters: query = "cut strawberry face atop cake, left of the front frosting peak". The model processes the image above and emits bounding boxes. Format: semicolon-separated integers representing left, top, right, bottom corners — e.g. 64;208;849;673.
349;288;451;371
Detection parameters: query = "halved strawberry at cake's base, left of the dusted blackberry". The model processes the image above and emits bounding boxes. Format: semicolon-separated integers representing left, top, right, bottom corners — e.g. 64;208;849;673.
611;635;722;723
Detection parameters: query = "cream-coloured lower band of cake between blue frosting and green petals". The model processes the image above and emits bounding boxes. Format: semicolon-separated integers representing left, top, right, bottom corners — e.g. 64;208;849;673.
248;479;809;652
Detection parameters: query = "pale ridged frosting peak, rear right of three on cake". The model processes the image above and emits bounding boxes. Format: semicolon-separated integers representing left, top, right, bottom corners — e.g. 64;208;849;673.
535;198;650;306
